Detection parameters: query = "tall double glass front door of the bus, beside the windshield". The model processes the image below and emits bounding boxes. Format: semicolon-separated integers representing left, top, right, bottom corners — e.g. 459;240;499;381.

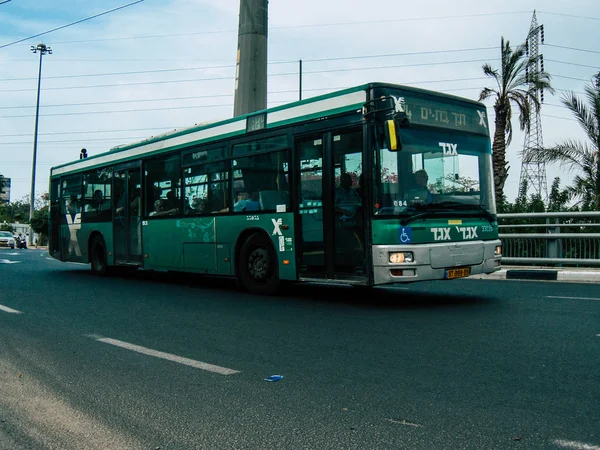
296;128;367;282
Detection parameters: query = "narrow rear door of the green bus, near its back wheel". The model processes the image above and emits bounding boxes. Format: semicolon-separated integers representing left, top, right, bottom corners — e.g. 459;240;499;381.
113;166;142;265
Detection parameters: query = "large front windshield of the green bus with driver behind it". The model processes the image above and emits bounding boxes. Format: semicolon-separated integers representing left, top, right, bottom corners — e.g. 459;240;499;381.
373;128;496;217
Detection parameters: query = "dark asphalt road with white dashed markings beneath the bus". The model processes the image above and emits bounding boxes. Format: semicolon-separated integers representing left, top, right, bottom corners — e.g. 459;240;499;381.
0;249;600;450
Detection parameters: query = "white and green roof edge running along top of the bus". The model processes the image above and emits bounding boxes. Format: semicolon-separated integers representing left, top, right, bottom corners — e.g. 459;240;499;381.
50;82;485;177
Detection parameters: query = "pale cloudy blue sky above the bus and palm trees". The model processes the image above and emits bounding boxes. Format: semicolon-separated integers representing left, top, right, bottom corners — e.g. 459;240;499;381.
0;0;600;201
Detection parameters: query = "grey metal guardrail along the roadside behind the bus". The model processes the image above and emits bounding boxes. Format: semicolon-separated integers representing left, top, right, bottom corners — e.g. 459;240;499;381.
498;211;600;267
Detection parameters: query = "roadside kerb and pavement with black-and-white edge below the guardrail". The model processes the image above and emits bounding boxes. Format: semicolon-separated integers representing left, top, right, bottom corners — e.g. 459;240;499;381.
471;266;600;283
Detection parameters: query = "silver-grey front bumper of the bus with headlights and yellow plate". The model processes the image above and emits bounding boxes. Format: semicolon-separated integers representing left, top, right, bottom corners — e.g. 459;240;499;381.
373;239;502;285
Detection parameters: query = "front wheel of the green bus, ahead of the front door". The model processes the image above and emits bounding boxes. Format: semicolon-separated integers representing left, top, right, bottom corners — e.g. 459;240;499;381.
238;233;279;295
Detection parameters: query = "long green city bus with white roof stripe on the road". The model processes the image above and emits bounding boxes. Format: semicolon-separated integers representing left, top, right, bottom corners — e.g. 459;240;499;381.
49;83;501;294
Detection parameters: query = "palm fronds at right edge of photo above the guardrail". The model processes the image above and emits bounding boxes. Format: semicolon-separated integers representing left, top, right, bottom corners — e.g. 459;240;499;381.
524;72;600;210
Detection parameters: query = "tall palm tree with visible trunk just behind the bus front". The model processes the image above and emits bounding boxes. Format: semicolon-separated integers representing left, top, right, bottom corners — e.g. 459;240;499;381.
479;37;554;205
